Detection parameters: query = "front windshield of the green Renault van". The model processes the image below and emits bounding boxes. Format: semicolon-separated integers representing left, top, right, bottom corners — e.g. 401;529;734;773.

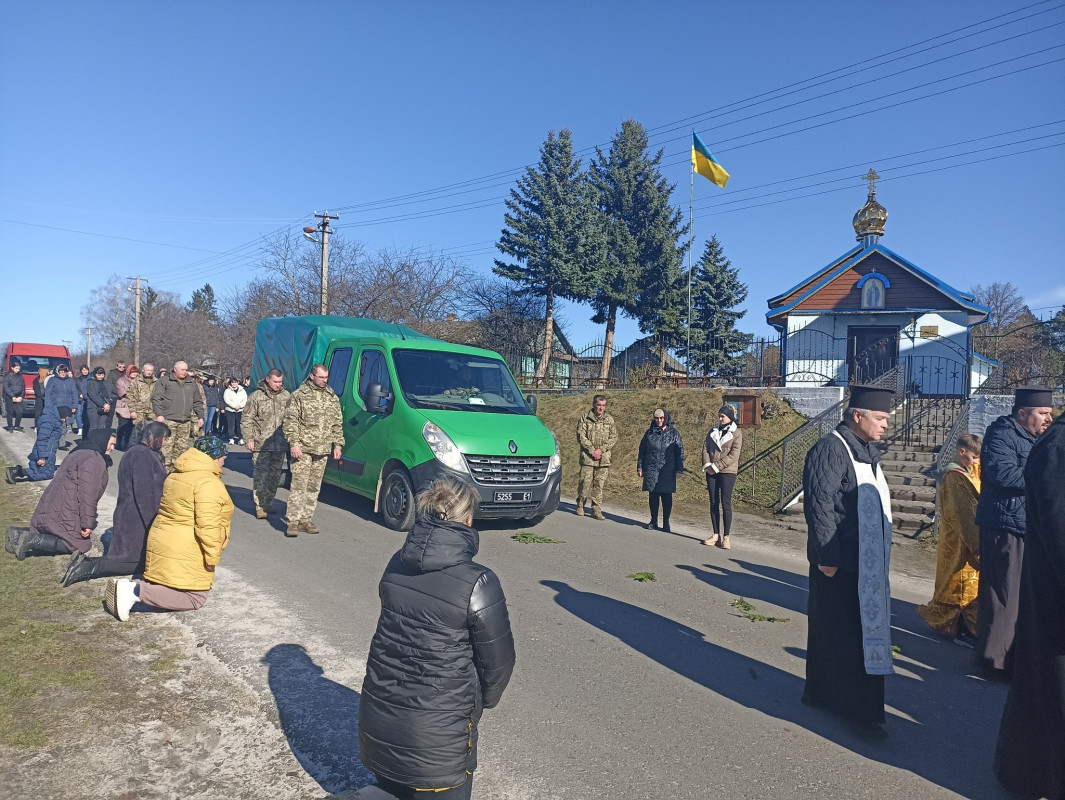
392;349;533;414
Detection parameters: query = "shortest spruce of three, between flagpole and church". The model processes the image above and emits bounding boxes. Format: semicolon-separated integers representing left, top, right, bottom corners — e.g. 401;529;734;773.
681;236;753;375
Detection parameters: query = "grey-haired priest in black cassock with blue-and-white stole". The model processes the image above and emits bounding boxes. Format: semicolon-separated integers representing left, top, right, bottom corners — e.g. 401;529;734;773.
802;386;895;738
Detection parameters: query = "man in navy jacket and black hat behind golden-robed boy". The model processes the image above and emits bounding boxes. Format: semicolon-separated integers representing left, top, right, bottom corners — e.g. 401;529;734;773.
977;387;1051;677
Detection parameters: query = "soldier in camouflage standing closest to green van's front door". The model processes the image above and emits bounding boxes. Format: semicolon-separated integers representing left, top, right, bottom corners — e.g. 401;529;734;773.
282;364;344;537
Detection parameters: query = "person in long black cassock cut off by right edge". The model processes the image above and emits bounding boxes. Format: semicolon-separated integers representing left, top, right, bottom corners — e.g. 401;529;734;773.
995;415;1065;800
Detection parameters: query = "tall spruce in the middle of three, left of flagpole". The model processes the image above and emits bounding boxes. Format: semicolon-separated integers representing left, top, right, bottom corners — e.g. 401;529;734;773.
589;119;687;379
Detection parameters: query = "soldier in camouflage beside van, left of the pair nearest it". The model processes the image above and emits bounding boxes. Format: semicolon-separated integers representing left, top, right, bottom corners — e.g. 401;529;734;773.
241;370;292;520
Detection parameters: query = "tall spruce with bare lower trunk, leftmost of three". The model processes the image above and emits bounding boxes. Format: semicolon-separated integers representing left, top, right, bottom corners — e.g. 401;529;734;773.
493;129;604;378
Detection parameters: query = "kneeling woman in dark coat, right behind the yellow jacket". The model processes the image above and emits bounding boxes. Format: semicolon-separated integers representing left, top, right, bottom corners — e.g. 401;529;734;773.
63;422;170;586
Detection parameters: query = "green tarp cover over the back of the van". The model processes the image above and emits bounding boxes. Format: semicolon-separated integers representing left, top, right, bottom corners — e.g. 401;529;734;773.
251;314;432;391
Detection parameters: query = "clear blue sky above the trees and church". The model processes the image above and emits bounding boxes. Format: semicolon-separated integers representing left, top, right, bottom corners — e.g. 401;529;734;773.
0;0;1065;355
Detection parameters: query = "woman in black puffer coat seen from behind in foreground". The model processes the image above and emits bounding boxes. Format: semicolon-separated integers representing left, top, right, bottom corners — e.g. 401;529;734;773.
359;478;514;800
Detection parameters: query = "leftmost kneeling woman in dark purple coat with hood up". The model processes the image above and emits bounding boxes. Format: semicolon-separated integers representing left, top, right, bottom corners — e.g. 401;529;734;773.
6;428;115;561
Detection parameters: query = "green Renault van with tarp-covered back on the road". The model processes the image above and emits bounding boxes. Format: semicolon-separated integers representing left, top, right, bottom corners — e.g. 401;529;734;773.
251;315;562;530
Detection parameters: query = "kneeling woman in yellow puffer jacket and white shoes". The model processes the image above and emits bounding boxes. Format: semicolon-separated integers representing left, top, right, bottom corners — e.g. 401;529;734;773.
104;436;233;622
